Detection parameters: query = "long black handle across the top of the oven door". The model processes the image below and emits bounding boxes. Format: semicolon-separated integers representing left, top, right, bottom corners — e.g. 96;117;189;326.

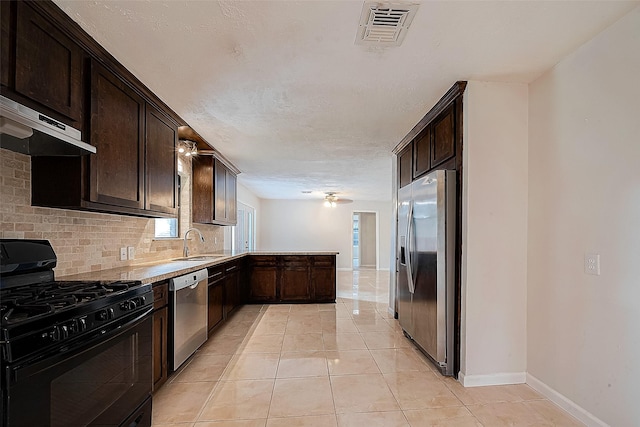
9;306;153;383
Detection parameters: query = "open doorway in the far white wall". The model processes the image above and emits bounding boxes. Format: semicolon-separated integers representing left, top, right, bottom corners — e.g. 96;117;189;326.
352;212;378;270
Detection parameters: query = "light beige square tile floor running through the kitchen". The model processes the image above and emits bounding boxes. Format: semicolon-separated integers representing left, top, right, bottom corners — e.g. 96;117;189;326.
153;270;582;427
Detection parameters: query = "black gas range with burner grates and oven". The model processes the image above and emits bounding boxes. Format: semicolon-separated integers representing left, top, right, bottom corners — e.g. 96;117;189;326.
0;239;153;427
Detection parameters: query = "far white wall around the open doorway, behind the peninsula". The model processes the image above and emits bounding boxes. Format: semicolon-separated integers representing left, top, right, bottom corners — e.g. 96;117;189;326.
257;199;392;269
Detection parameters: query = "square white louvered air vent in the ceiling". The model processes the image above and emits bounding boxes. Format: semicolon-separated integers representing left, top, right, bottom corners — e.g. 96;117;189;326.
356;2;418;46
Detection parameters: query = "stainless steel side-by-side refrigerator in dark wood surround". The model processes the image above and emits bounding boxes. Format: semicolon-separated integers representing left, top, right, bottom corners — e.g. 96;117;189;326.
396;170;456;375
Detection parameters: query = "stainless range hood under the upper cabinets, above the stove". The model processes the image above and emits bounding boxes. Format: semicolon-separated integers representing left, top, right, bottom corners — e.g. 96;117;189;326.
0;95;96;156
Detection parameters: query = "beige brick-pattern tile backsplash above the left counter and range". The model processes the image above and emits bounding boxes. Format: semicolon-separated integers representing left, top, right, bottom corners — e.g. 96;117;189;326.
0;149;224;278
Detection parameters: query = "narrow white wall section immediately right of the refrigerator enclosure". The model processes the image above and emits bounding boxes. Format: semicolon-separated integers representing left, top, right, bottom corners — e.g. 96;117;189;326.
460;81;528;386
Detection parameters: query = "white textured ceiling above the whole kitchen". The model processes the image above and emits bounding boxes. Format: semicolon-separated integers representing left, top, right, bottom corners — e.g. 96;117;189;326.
54;0;639;200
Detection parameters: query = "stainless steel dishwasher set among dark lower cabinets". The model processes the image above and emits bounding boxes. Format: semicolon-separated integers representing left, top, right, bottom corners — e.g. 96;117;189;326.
169;268;208;370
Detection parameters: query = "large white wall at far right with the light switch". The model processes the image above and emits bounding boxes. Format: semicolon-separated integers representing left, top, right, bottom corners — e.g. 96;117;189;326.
527;8;640;426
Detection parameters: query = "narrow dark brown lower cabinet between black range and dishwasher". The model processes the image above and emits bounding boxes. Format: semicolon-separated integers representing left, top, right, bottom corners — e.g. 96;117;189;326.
152;281;169;391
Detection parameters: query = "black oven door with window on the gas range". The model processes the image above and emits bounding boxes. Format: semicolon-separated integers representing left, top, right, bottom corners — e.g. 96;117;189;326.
4;310;153;427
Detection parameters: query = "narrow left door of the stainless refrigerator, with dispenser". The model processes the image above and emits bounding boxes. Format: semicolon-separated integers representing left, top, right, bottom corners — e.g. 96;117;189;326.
396;185;413;335
